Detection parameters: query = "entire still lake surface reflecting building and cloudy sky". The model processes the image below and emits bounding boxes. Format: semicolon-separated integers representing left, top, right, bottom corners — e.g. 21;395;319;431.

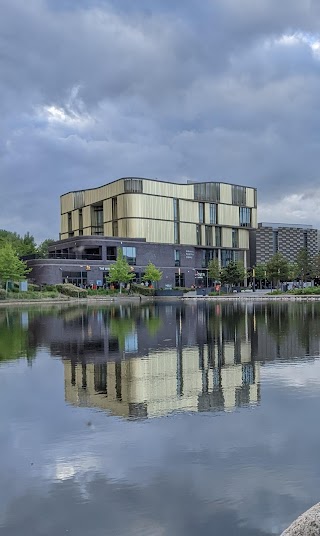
0;302;320;536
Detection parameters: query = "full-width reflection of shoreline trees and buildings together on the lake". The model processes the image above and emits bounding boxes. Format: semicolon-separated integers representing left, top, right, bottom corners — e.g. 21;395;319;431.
6;301;320;418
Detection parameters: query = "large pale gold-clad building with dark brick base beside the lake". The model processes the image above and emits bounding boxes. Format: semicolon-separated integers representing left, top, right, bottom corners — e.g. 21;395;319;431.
29;177;257;287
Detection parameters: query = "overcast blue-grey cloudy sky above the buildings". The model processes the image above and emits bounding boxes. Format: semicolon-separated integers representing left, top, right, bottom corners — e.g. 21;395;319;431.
0;0;320;242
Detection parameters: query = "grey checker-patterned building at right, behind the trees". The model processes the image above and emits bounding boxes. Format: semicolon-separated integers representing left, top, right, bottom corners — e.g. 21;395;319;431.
250;223;318;266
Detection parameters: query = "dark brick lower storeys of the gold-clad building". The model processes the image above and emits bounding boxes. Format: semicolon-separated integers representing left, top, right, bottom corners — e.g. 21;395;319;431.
28;237;218;287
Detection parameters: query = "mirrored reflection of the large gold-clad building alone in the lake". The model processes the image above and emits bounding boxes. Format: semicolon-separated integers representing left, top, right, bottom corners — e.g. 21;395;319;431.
57;304;260;418
